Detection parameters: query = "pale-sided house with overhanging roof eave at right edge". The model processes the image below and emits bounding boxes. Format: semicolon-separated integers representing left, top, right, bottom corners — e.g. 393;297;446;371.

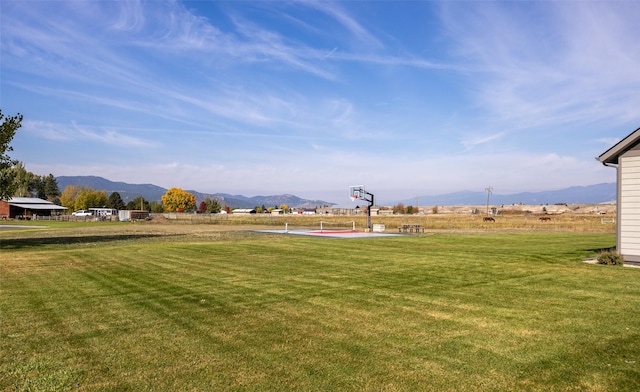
597;128;640;262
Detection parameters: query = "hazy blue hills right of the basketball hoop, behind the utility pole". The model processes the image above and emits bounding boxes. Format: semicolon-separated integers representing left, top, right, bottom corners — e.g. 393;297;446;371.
396;183;616;206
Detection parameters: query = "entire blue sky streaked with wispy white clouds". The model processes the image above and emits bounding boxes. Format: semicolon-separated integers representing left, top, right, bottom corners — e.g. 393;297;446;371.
0;0;640;203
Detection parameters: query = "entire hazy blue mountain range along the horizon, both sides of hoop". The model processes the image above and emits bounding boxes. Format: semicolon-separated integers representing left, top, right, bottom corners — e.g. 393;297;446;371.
56;176;616;208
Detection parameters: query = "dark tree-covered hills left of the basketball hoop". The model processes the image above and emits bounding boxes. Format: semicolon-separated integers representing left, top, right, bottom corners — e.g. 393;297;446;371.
56;176;334;208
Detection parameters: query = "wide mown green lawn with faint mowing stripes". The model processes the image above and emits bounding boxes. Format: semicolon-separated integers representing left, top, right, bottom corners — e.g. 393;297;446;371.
0;222;640;391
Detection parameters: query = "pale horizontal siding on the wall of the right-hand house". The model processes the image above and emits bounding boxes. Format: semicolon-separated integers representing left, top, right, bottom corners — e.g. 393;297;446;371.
618;155;640;261
